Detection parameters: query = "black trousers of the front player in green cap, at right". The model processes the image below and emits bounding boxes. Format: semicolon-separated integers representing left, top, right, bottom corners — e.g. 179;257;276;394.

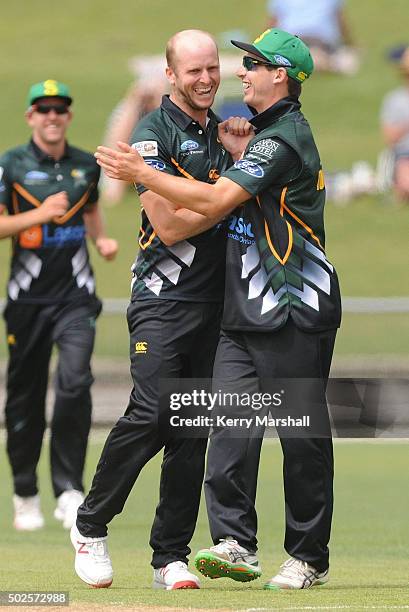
205;319;336;571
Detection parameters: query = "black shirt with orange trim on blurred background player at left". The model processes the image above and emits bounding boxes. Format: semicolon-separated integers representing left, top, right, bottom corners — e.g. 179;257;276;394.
0;140;100;304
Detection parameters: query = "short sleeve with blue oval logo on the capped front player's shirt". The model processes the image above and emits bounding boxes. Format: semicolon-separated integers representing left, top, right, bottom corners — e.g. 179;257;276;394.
222;137;301;197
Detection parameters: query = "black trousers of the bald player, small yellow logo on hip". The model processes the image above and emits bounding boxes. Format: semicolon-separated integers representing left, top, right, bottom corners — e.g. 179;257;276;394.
77;299;222;568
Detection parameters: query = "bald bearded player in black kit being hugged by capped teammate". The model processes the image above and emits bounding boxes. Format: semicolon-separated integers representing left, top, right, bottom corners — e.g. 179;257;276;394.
71;30;231;590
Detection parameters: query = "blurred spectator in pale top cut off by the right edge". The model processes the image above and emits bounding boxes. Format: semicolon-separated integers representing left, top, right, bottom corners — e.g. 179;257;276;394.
381;46;409;201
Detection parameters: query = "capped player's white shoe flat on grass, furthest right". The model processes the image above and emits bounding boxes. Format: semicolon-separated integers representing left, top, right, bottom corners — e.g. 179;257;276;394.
264;557;329;591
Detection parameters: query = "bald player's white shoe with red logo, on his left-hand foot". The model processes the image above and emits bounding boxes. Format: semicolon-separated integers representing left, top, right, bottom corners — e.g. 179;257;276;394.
70;523;114;589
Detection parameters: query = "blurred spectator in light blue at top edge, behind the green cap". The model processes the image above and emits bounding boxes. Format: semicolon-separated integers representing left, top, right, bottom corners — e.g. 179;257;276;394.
267;0;359;74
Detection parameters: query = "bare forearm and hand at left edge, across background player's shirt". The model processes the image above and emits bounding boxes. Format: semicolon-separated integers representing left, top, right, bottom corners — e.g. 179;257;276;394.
0;191;68;239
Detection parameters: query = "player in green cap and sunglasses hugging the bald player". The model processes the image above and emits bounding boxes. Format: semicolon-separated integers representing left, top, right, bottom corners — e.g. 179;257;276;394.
96;29;341;589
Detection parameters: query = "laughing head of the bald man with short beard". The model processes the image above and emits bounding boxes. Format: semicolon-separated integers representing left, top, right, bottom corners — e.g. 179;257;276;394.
166;32;220;120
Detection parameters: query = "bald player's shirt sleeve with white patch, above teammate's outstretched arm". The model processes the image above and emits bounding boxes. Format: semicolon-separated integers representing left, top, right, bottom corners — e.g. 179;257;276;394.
131;124;176;195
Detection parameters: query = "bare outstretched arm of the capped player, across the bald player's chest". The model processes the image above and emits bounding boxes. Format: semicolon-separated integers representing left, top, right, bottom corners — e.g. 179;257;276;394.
95;143;251;222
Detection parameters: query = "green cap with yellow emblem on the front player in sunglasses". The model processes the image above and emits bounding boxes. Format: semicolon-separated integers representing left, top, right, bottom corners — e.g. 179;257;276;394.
231;29;314;83
